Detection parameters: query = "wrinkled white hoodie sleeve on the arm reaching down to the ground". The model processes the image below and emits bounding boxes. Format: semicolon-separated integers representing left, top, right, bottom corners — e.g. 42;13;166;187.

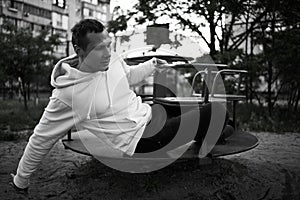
14;97;76;188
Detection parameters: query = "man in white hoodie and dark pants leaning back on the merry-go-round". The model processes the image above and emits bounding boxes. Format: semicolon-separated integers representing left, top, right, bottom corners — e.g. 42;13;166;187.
12;19;230;191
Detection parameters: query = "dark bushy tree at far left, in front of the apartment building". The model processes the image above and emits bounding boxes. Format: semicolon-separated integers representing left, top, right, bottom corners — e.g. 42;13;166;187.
0;22;60;109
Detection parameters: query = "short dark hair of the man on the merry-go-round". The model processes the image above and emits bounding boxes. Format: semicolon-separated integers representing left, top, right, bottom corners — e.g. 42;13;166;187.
71;19;104;50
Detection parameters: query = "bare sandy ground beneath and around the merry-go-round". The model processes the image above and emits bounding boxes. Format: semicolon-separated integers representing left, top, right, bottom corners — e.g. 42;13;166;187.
0;133;300;200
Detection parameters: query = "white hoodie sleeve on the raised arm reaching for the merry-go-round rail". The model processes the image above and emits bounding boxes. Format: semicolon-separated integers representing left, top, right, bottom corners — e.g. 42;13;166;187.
122;58;157;86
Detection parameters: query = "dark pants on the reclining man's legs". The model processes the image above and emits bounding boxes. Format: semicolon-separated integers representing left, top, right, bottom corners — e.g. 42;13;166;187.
135;103;228;153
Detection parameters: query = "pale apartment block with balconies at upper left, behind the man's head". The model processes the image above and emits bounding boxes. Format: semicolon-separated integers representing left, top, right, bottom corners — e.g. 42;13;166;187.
0;0;110;58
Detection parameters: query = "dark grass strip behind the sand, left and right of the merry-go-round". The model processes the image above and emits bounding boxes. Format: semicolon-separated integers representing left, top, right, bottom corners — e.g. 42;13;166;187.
0;100;300;141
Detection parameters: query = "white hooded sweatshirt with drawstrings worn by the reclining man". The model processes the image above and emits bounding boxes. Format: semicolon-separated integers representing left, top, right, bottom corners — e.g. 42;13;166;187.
14;48;156;188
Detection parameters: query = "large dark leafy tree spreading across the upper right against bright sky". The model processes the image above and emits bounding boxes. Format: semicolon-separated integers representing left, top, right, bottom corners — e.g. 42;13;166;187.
110;0;300;114
